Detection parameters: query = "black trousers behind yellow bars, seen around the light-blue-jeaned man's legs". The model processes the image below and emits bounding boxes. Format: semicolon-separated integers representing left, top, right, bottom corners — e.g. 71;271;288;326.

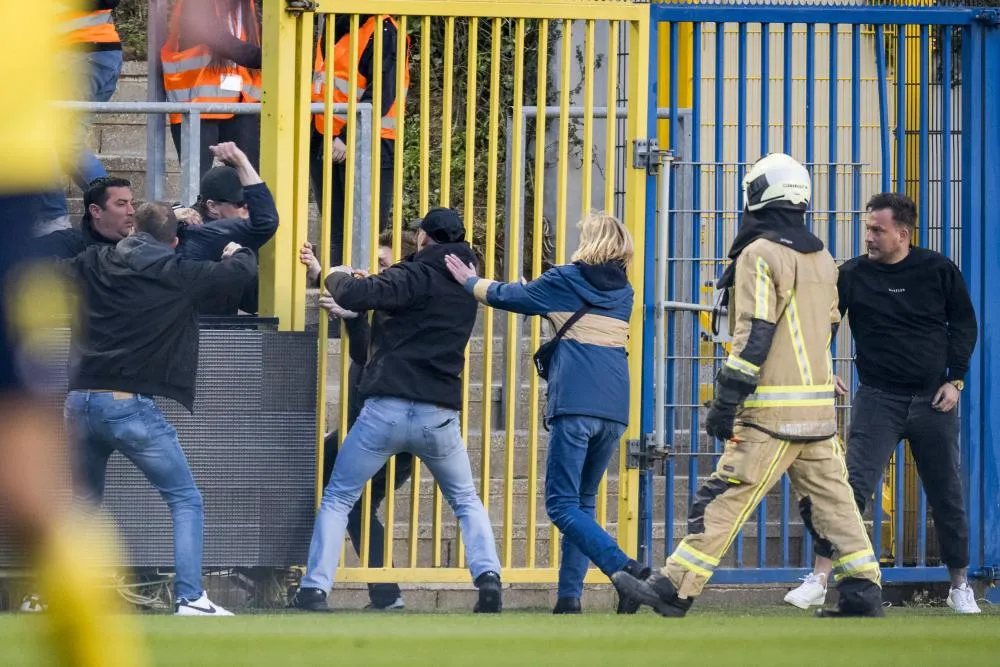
323;431;413;607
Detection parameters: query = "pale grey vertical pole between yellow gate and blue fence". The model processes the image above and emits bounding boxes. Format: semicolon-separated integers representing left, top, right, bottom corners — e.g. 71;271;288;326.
653;154;673;448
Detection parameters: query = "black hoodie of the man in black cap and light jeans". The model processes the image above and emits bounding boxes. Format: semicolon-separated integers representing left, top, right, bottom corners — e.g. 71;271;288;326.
326;242;478;410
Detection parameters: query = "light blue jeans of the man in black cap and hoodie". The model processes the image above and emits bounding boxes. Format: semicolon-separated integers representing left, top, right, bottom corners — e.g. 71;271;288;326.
302;397;500;591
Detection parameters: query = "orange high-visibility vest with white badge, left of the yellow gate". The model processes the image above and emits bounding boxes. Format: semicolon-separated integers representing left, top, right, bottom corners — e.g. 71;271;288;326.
160;0;262;124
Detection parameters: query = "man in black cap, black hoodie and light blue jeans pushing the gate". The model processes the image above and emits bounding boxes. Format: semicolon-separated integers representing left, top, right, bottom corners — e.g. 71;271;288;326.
291;209;501;613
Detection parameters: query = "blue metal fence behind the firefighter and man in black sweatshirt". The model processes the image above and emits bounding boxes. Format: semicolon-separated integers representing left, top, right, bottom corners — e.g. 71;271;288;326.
641;4;1000;583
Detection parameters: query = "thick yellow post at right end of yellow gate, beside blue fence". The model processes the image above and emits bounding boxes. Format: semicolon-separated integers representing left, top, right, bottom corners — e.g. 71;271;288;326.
617;13;650;557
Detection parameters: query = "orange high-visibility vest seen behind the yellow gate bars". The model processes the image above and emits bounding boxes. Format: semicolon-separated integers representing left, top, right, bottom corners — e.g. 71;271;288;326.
312;16;410;139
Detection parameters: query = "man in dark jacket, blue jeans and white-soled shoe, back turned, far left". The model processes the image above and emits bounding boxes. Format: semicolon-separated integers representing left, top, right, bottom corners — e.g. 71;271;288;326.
64;202;256;616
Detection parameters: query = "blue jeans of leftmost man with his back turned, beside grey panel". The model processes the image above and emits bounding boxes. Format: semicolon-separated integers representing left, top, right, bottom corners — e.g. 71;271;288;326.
64;391;205;601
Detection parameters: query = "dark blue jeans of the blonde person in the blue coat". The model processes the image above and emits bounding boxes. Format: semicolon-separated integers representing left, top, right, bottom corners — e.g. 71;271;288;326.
545;415;629;598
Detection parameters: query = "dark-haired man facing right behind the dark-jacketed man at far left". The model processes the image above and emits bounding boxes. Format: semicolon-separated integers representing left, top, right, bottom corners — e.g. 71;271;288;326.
32;176;135;259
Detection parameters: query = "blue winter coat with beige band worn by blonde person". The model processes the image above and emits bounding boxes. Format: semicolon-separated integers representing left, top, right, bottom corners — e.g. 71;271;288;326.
465;262;633;425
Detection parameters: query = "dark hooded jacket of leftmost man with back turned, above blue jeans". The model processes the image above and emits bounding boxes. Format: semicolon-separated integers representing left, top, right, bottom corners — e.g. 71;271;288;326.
63;232;257;410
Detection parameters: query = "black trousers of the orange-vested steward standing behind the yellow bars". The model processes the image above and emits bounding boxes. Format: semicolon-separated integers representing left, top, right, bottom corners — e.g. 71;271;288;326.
309;130;395;266
